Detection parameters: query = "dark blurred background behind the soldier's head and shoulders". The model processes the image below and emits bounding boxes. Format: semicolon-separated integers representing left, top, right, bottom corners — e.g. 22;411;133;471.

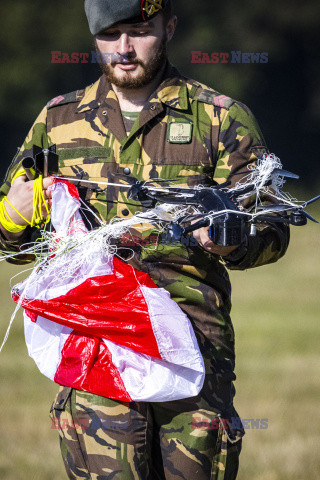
0;0;320;187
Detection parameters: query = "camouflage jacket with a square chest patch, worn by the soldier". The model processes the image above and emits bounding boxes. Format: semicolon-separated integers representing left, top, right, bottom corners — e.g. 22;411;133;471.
1;64;289;410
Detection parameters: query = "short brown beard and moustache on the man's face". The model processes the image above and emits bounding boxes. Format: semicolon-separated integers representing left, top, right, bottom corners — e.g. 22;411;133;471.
95;35;167;90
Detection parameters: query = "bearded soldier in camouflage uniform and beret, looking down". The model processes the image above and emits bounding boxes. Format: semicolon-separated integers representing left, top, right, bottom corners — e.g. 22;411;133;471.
0;0;289;480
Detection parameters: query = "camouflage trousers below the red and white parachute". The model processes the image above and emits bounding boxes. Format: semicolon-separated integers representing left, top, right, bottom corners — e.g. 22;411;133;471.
50;387;241;480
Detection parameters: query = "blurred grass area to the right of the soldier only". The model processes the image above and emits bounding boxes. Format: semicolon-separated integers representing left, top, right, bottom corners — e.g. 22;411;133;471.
231;207;320;480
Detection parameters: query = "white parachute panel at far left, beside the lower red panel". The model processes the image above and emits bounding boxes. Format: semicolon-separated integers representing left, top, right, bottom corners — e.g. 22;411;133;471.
24;312;72;381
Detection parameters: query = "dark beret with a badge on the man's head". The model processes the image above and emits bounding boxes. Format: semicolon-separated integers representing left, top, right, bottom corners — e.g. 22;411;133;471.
85;0;171;35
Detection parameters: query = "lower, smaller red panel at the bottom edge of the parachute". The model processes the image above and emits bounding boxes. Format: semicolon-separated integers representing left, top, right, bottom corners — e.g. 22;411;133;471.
54;331;132;402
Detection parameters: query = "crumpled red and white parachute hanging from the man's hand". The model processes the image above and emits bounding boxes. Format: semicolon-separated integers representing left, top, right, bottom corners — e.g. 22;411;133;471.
12;179;204;402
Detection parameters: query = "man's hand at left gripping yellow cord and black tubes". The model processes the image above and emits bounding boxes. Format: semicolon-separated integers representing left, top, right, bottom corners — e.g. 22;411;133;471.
1;175;53;238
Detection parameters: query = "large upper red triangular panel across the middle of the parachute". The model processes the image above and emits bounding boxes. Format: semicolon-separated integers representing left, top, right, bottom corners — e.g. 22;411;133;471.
13;257;161;358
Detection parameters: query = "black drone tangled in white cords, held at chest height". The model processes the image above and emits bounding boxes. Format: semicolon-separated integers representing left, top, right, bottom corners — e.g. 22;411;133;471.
128;164;320;247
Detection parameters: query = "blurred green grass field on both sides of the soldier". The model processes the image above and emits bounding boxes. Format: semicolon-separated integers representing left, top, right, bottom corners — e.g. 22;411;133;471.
0;214;320;480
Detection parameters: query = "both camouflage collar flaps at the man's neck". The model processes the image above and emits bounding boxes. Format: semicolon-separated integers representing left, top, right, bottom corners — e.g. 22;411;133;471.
77;62;189;113
